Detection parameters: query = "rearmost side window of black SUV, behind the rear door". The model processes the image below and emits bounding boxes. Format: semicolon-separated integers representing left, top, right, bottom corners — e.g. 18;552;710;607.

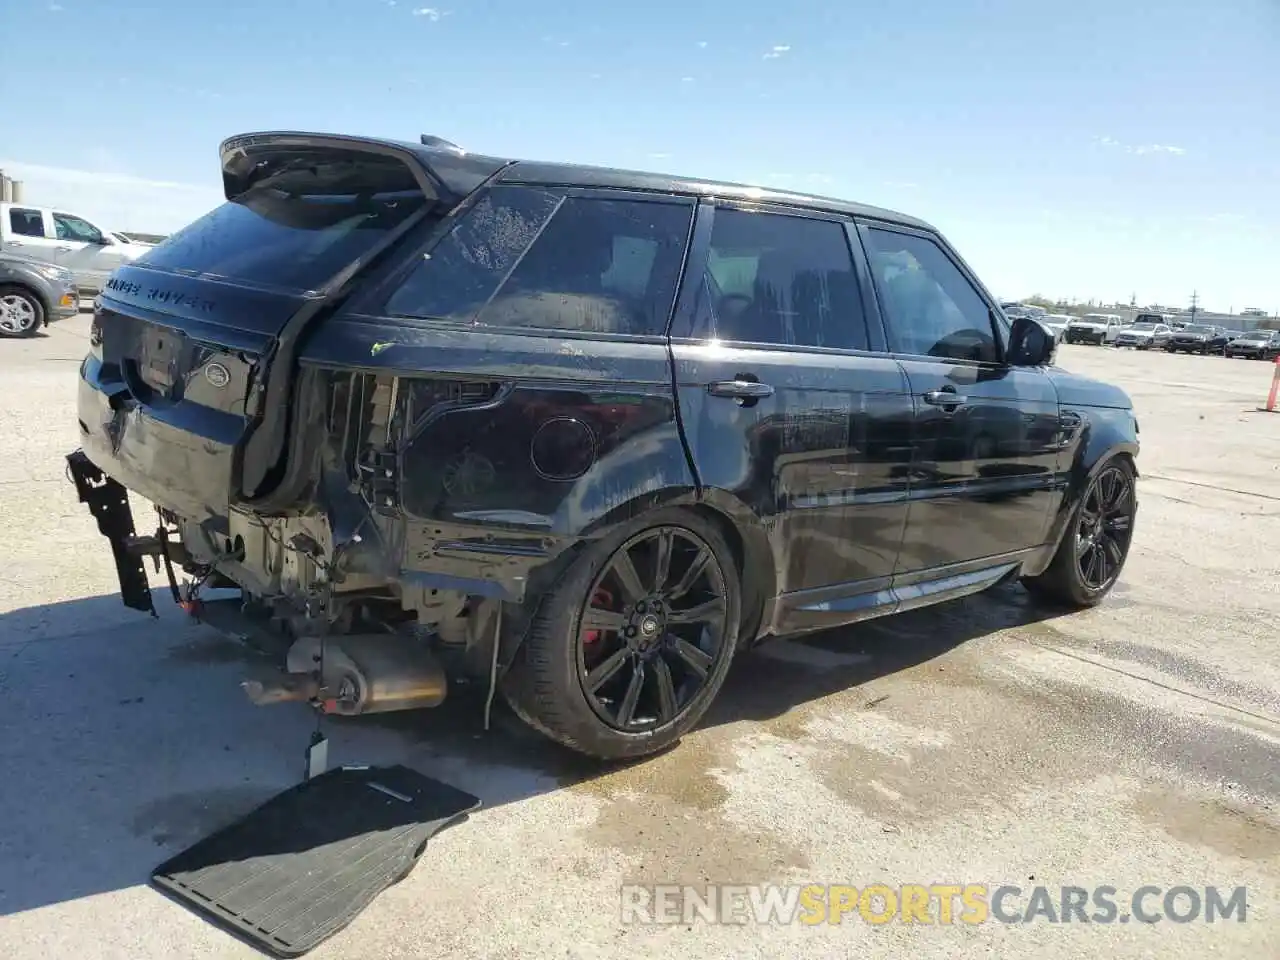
387;187;692;335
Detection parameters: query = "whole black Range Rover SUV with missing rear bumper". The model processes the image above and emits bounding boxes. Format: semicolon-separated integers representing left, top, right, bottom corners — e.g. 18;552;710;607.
68;133;1138;758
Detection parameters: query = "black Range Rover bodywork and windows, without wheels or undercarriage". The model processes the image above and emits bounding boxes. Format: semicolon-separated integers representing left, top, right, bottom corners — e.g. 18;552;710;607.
67;133;1137;696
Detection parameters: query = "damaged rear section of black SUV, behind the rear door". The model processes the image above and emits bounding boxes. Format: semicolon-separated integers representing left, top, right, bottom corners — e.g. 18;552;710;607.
69;133;721;755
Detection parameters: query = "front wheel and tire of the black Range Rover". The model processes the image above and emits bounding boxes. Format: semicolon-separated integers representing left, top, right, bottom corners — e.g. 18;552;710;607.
1023;456;1138;609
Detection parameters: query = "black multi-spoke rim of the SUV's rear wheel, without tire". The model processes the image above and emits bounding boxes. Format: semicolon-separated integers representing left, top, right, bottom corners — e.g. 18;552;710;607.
575;526;731;733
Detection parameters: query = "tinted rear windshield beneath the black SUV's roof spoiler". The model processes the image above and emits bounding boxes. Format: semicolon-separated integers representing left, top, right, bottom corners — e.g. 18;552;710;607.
138;150;434;292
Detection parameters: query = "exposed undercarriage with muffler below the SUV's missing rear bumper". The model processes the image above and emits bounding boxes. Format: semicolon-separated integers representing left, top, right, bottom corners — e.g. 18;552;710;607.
68;452;500;716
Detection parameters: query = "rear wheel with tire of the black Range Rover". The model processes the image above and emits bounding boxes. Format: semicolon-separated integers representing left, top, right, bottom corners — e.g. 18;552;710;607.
503;509;741;760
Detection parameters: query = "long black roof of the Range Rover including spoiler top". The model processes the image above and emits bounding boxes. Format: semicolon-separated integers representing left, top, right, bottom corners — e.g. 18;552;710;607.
220;131;937;233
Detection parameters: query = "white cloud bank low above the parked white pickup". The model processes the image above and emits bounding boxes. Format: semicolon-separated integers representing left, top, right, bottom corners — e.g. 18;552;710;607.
0;156;223;233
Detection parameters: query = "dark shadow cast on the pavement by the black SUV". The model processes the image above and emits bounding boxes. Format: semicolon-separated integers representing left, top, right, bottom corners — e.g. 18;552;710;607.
0;586;1064;916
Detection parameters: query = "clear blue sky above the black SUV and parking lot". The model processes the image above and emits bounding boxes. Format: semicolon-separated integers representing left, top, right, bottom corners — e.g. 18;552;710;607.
0;0;1280;312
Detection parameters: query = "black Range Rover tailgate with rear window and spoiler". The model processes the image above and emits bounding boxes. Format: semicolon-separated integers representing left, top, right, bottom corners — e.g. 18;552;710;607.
78;134;447;518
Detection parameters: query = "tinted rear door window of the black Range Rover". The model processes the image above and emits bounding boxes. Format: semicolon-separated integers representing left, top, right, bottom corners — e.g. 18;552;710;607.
692;209;868;349
